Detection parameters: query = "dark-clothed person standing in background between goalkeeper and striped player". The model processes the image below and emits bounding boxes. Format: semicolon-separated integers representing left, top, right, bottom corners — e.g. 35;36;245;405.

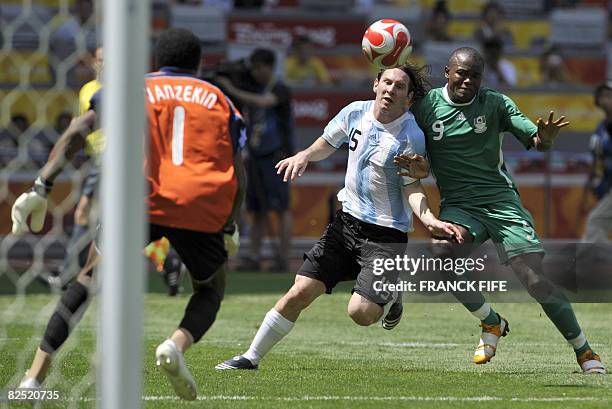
214;48;294;271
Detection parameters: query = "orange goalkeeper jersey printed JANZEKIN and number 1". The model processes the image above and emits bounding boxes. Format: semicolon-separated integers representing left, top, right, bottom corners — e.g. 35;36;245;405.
145;68;246;233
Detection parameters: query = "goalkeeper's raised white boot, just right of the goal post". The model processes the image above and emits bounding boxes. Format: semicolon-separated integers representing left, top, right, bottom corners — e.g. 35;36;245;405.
155;339;198;400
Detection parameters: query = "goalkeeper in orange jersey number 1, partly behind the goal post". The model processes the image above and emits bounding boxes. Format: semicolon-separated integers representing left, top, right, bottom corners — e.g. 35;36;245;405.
11;29;246;400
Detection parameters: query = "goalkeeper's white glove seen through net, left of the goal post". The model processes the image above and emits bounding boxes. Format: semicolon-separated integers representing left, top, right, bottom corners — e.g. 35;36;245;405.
11;176;53;236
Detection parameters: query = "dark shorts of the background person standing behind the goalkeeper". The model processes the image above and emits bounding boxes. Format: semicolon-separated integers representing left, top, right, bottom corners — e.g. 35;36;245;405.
246;154;289;212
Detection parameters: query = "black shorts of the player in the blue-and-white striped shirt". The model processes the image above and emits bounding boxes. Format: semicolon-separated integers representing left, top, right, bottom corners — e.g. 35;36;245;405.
297;210;408;305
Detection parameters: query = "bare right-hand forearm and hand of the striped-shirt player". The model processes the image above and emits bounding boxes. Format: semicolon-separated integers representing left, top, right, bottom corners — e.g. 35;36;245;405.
404;181;463;243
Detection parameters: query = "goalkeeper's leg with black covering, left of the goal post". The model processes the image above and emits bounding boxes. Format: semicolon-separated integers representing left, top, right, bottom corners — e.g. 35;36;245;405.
19;243;99;388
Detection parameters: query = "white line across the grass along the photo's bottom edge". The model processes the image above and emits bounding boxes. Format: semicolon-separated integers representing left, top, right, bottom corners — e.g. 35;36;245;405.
80;395;612;402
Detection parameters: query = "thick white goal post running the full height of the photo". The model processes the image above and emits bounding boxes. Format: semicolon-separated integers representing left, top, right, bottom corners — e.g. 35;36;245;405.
98;0;150;409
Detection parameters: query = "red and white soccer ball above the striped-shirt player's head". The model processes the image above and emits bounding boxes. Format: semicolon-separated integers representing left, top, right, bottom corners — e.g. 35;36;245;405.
361;19;412;69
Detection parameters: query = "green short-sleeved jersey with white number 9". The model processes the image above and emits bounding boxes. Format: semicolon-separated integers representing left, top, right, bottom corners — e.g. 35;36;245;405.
410;86;538;205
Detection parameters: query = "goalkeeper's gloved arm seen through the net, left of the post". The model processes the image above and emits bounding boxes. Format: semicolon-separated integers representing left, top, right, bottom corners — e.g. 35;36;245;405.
11;111;96;235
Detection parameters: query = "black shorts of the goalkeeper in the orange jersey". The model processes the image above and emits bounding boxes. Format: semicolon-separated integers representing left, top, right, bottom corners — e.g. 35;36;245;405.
149;223;227;282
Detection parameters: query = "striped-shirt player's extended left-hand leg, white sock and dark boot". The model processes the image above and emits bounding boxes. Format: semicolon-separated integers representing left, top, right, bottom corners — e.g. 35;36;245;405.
215;275;325;369
